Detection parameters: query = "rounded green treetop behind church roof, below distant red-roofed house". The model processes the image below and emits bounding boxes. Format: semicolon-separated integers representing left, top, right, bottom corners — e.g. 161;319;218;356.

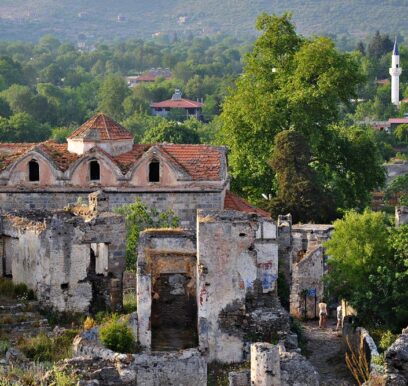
142;121;200;143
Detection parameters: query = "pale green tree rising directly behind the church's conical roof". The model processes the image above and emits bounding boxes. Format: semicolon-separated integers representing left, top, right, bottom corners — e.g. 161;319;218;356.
99;74;129;119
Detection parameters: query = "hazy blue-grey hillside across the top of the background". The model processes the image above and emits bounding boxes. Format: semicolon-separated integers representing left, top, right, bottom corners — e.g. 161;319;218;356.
0;0;408;40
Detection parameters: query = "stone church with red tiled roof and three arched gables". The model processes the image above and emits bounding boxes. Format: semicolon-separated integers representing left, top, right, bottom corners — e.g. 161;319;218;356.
0;114;268;228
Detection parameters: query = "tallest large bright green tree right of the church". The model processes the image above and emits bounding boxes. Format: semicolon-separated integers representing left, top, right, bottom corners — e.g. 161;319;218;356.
219;14;383;208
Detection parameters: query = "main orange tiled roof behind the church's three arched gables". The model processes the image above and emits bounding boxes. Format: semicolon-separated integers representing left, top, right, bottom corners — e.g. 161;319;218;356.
0;141;223;181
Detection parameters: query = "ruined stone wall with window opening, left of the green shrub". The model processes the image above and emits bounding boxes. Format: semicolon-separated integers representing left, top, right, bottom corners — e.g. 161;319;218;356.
1;191;125;312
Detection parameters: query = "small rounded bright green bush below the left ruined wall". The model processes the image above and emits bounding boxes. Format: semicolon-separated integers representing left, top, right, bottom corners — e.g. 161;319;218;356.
99;317;136;353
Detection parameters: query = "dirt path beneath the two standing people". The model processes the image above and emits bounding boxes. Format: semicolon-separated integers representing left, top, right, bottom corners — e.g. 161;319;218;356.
302;320;356;386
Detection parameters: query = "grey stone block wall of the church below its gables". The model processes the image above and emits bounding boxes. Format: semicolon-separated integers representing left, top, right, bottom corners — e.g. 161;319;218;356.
0;188;225;229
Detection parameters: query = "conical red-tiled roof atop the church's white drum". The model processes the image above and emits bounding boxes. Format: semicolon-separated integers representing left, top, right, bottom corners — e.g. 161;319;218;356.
68;113;133;140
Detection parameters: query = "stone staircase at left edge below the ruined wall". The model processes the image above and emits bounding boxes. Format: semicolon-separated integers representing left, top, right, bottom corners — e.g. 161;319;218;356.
0;301;51;344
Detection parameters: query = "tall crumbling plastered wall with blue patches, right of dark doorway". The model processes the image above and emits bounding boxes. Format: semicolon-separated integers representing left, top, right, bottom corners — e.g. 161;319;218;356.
197;211;288;363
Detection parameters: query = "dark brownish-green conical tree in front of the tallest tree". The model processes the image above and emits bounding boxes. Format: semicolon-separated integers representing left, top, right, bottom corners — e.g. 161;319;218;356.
269;130;335;222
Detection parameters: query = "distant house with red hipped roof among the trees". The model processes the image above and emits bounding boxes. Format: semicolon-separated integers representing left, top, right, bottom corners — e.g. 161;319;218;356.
150;89;204;119
